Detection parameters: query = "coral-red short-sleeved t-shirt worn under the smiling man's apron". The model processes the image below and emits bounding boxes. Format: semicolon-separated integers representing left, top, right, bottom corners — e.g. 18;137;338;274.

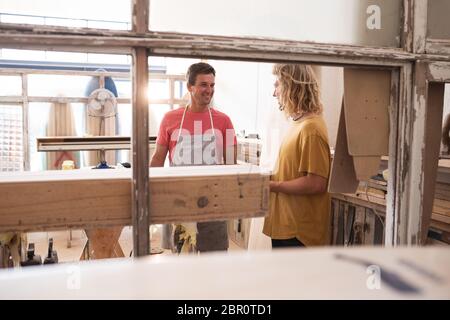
156;107;237;163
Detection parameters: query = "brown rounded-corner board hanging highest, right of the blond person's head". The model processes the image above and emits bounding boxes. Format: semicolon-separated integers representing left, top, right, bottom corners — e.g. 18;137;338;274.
344;68;391;156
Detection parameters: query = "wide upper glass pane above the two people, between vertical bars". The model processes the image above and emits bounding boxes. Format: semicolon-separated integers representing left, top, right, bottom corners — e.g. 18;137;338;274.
149;0;402;47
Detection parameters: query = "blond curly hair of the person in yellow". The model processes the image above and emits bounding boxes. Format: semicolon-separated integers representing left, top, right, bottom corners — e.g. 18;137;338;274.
272;64;323;116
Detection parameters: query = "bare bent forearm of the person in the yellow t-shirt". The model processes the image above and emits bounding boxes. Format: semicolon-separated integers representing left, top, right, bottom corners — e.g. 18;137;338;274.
270;173;327;195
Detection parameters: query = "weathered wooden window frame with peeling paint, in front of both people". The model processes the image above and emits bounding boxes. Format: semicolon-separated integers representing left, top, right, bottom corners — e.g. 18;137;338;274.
0;0;450;251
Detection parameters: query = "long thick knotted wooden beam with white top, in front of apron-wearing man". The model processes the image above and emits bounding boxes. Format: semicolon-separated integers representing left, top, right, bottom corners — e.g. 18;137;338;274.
0;165;269;232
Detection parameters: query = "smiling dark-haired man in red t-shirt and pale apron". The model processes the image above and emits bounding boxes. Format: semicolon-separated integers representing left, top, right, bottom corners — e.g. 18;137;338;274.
150;62;236;252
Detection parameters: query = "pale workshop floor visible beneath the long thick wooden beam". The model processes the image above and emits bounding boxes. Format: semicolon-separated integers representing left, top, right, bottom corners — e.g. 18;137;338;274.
27;225;244;262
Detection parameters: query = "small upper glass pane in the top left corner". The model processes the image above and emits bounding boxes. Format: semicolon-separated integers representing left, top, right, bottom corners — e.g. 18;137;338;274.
0;0;131;30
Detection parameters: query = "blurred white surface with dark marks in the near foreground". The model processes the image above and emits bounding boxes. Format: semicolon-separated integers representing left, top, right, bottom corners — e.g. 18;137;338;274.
0;247;450;300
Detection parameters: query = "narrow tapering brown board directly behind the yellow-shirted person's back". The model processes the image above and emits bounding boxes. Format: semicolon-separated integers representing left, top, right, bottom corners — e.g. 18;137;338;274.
328;100;359;193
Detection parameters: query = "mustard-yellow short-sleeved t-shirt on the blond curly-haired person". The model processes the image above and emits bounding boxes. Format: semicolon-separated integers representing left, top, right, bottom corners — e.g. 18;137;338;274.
263;115;331;246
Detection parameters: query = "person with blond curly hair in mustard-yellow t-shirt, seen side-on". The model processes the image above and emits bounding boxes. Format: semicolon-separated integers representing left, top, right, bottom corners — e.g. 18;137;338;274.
263;64;331;248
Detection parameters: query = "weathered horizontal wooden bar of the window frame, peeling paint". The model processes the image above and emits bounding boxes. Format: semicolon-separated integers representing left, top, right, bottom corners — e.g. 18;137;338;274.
0;24;440;65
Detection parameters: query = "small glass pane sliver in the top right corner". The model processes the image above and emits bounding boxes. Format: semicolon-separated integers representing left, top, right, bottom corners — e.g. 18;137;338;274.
427;0;450;40
